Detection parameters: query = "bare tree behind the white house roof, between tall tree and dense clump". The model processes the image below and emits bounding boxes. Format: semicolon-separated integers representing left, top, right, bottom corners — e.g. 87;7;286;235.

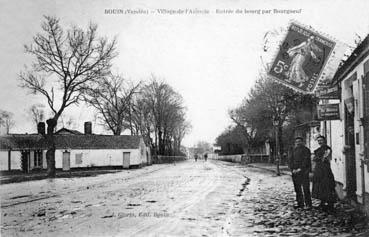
84;74;140;135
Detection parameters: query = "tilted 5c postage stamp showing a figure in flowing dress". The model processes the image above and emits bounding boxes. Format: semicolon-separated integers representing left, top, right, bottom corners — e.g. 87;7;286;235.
268;22;336;93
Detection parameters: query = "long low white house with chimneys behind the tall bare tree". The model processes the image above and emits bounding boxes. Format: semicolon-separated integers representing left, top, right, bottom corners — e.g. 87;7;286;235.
0;123;151;172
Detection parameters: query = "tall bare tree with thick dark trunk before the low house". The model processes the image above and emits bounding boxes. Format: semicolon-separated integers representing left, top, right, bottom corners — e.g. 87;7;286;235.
19;16;117;177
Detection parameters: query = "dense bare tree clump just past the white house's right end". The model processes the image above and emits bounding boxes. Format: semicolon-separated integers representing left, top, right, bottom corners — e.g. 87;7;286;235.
131;76;189;155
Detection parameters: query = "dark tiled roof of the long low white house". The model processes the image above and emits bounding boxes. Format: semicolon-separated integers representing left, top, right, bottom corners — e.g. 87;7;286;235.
0;134;141;150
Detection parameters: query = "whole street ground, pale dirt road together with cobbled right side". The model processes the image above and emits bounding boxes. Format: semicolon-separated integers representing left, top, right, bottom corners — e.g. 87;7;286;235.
0;161;369;236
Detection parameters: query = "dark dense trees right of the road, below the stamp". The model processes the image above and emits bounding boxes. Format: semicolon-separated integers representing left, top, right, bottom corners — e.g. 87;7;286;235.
216;74;317;157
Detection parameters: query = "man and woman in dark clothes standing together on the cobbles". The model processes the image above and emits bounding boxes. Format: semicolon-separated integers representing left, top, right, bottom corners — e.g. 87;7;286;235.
289;136;336;211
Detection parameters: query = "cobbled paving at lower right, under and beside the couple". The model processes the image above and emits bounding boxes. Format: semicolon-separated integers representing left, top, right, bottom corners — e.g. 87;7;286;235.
229;164;369;237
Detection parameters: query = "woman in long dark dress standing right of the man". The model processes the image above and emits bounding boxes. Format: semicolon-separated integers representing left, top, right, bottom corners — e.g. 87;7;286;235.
312;136;336;210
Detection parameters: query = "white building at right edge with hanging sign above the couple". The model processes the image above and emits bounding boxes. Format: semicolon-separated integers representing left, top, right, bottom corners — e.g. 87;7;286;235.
321;33;369;213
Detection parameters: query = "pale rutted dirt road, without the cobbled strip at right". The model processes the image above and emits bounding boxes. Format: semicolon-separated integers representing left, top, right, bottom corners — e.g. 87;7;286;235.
1;161;246;236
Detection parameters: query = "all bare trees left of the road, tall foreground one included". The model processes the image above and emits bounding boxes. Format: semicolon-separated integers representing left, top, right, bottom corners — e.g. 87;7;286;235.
19;16;190;176
